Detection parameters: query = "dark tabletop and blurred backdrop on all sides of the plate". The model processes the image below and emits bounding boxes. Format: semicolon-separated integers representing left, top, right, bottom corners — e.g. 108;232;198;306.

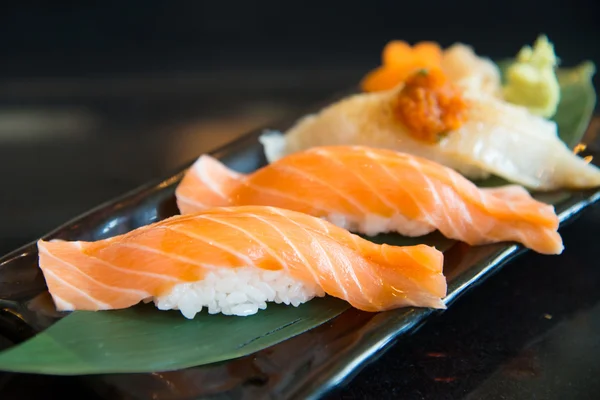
0;0;600;399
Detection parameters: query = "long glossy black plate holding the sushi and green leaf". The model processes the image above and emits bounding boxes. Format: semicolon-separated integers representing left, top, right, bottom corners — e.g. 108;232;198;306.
0;101;600;400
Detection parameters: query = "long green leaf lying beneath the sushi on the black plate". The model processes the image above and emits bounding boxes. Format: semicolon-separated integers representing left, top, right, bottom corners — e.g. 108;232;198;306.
0;59;596;375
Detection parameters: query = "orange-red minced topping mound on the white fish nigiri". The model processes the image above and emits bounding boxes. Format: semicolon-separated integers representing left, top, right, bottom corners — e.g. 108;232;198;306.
394;68;468;143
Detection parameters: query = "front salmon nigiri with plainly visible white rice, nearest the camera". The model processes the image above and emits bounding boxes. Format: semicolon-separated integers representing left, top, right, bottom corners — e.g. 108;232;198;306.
38;206;447;319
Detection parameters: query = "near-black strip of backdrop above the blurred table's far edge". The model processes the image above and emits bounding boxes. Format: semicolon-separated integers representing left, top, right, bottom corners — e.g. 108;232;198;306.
0;0;600;77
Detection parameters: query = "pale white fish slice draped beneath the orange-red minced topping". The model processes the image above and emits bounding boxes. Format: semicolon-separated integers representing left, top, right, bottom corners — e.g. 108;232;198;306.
260;77;600;190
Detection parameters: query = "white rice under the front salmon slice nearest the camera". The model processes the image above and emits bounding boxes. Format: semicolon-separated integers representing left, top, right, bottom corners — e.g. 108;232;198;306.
152;267;325;319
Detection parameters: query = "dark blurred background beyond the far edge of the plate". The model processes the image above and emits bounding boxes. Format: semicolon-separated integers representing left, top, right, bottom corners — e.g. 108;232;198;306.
0;0;600;253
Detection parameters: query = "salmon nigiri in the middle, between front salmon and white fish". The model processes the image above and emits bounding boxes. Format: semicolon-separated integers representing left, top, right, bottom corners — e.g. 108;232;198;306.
176;146;563;254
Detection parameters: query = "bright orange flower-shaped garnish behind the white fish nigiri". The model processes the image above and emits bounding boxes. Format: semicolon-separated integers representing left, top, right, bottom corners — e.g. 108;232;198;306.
361;40;442;92
